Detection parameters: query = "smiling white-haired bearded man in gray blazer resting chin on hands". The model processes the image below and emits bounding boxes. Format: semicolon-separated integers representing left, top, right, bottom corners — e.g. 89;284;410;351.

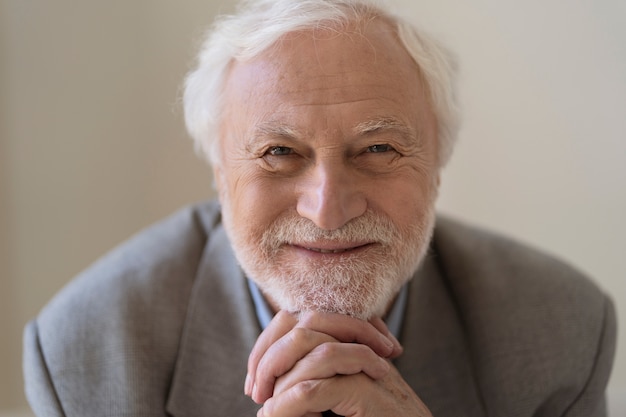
25;0;615;417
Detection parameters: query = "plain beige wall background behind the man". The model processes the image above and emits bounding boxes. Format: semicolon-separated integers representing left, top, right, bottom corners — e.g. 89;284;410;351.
0;0;626;415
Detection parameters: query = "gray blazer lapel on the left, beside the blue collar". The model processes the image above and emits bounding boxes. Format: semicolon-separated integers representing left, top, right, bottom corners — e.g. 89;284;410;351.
167;225;260;417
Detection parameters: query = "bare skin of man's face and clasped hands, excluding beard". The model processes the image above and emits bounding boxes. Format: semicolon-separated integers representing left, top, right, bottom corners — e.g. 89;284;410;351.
214;15;439;417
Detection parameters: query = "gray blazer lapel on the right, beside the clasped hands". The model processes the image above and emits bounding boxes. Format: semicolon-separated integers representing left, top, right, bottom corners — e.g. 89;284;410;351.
396;247;486;416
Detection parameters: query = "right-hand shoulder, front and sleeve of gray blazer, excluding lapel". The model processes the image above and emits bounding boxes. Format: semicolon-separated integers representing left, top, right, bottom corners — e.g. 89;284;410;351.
434;217;616;415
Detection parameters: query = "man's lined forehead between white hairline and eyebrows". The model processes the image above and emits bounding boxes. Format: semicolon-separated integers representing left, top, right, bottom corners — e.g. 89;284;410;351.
224;19;430;136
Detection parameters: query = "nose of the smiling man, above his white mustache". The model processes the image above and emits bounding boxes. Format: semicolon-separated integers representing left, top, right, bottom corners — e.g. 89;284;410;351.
297;161;367;230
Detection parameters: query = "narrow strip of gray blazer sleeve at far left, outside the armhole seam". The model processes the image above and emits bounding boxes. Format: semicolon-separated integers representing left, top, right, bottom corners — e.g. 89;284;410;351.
24;321;65;417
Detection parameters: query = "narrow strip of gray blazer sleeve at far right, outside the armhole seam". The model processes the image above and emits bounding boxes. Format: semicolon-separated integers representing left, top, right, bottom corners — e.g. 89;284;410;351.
564;297;617;417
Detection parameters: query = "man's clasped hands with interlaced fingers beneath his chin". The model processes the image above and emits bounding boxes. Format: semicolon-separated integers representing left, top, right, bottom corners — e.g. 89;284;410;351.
244;311;431;417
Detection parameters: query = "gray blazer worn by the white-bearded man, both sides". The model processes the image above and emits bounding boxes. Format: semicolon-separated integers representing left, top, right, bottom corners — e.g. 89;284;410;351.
24;202;616;417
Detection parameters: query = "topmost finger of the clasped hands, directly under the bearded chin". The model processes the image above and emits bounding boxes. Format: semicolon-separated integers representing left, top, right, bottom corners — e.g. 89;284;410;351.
297;311;396;358
